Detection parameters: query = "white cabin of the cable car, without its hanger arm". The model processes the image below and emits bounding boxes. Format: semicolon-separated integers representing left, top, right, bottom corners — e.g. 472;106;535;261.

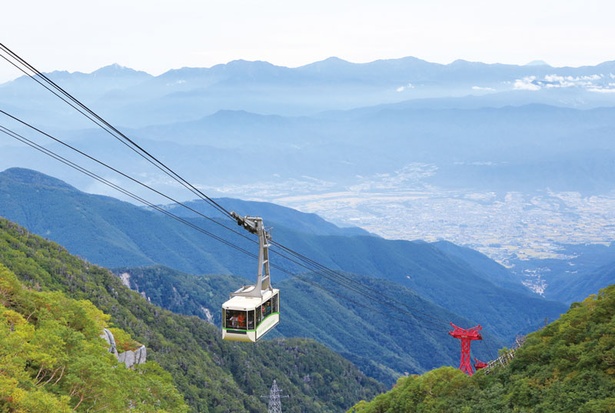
222;286;280;342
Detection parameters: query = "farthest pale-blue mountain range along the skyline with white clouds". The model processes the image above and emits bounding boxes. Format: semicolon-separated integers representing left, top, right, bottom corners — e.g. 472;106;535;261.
0;57;615;127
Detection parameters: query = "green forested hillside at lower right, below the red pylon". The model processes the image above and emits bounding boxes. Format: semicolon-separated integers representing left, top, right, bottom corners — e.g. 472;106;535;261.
349;285;615;413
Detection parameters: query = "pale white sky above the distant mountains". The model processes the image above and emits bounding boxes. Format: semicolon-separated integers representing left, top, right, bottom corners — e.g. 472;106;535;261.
0;0;615;83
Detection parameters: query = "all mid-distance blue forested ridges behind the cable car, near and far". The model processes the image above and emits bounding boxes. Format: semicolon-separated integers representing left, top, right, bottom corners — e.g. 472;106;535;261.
0;169;566;384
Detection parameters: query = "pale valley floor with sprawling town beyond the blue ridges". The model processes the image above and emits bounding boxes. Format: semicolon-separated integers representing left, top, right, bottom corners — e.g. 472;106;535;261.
190;164;615;294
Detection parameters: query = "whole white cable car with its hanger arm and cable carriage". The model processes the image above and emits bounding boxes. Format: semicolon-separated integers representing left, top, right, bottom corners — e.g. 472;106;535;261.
222;212;280;342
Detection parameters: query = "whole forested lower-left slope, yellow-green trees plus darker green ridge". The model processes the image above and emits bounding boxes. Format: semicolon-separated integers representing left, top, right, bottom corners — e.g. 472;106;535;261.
0;218;385;413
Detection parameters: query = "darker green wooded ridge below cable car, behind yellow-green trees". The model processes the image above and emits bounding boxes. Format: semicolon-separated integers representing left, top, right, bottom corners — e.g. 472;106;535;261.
0;219;383;413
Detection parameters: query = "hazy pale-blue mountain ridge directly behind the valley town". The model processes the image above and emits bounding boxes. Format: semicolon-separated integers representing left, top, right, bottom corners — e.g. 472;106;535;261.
1;105;615;199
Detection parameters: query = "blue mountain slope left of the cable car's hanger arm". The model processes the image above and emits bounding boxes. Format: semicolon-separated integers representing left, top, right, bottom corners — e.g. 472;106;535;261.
0;168;253;273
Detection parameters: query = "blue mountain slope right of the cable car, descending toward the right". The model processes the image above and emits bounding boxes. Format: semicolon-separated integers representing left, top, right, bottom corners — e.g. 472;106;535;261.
279;234;565;342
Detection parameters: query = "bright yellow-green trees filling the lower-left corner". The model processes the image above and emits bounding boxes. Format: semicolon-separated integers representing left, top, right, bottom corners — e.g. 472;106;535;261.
0;264;188;413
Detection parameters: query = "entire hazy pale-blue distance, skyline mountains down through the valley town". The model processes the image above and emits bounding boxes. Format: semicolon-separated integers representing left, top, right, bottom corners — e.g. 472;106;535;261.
0;57;615;282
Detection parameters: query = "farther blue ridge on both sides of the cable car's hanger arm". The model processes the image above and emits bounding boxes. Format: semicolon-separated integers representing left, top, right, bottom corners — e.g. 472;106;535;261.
0;169;565;348
